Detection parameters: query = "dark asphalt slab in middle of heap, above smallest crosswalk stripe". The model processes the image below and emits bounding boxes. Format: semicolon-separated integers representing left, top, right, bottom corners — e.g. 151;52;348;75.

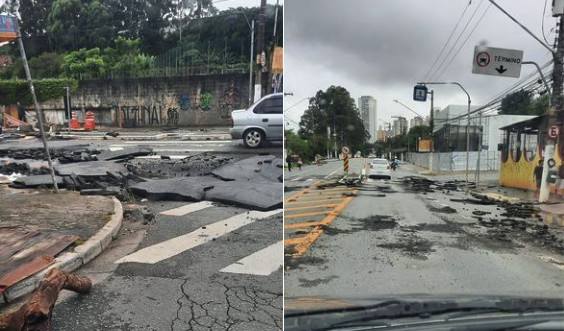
130;177;221;201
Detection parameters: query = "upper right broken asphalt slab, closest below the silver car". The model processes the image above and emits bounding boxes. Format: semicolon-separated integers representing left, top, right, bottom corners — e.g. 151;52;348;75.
212;155;283;183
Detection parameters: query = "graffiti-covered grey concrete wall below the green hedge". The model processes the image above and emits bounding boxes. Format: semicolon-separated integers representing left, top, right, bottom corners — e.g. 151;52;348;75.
36;74;249;127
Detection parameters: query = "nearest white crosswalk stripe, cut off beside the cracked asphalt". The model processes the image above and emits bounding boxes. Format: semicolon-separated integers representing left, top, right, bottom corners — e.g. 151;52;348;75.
220;241;284;276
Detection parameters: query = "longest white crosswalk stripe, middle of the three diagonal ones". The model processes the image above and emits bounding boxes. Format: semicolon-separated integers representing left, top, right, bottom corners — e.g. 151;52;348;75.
114;209;282;264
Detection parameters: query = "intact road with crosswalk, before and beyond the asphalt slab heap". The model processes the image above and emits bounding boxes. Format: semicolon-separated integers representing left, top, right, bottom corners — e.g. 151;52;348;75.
0;139;283;331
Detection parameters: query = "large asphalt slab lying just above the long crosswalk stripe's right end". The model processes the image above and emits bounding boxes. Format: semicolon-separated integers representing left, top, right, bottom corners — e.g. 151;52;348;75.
205;181;284;211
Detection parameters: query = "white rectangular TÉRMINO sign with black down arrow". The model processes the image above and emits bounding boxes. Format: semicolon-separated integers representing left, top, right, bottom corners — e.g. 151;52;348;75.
472;46;523;78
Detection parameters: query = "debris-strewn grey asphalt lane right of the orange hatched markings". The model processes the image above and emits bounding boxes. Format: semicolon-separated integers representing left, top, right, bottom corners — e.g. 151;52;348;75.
285;159;564;298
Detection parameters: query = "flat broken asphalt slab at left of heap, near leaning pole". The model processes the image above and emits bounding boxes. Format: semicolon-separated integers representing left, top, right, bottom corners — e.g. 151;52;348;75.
55;161;127;178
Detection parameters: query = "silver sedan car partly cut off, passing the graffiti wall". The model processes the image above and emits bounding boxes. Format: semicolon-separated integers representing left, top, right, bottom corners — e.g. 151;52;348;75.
229;93;284;148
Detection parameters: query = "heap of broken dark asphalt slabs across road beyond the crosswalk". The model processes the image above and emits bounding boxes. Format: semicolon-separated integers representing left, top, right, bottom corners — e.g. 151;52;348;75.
2;147;283;210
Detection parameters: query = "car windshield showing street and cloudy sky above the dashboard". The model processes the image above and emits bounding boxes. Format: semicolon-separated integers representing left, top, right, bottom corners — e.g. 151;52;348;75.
284;0;564;324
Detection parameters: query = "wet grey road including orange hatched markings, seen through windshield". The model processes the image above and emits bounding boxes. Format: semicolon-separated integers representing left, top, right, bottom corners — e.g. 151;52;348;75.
284;159;564;298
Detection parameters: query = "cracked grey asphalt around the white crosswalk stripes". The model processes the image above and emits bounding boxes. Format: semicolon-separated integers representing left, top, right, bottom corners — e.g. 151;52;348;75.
49;202;283;331
